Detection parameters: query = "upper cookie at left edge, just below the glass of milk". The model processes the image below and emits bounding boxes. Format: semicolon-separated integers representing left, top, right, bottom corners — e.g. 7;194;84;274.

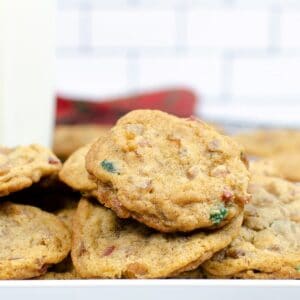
0;145;61;197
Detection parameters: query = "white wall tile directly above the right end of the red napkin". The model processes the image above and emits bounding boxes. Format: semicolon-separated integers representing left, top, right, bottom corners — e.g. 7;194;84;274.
138;54;222;97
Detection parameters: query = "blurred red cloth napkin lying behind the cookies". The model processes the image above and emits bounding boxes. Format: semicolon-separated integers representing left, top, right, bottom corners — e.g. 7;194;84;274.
56;89;196;124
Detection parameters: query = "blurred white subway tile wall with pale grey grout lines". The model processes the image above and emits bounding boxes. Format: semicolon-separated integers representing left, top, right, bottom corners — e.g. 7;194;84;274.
57;0;300;125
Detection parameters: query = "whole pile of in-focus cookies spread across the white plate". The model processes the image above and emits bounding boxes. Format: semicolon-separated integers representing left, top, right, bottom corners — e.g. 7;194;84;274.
0;110;300;279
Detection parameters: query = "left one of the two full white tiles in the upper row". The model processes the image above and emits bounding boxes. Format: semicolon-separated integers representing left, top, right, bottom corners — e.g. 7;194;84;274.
91;8;176;48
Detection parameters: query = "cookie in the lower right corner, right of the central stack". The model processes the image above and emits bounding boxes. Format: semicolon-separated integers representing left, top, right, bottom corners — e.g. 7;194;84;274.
202;176;300;278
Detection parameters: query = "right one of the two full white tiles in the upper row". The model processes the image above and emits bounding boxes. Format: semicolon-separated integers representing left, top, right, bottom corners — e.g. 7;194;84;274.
187;8;269;51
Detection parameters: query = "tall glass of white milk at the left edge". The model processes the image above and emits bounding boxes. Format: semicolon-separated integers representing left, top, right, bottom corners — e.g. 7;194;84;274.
0;0;56;146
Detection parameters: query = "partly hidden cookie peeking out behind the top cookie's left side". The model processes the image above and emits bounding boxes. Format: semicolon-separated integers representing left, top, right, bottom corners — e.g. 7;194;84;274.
59;144;97;196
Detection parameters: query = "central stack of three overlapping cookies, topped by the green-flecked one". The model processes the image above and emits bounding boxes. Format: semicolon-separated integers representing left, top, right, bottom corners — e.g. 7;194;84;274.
59;110;249;278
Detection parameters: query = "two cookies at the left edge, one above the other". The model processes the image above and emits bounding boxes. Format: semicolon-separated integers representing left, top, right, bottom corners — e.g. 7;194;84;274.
0;145;71;279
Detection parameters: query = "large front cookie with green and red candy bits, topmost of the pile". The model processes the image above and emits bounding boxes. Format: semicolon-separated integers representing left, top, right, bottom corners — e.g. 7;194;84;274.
86;110;249;232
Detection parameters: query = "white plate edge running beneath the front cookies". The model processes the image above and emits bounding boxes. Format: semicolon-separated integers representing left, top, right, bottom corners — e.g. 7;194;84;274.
0;279;300;300
